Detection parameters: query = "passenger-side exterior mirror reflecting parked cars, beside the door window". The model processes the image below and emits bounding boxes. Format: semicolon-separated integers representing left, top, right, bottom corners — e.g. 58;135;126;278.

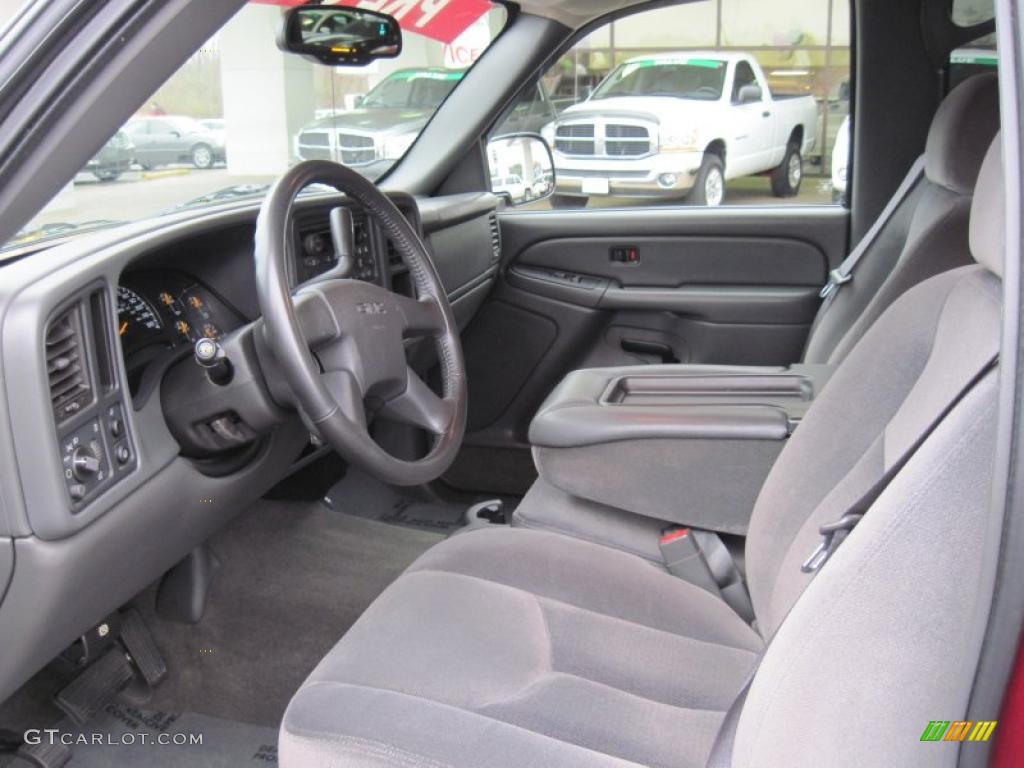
487;133;555;205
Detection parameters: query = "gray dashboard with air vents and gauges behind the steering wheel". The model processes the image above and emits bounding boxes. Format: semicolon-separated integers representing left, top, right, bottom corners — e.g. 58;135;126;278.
0;193;500;698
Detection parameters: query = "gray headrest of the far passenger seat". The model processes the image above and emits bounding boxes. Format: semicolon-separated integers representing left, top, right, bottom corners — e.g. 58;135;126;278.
925;74;999;195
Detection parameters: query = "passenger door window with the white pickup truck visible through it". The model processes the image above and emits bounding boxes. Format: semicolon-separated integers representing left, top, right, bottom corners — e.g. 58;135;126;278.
507;0;851;208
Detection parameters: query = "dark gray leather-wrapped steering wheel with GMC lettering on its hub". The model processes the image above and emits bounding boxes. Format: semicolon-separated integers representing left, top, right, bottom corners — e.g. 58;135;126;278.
256;160;466;485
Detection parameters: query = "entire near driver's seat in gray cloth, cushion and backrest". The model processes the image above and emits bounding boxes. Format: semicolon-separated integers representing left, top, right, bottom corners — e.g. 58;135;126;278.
280;148;1004;768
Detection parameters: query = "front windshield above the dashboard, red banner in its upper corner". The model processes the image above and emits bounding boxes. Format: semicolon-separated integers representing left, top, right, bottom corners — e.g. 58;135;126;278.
0;0;506;253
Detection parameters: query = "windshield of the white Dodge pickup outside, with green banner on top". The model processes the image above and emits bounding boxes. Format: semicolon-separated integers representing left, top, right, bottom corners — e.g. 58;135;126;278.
591;58;727;101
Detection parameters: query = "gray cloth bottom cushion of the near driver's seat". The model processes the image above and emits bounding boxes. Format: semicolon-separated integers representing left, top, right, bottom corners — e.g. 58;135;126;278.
281;529;762;766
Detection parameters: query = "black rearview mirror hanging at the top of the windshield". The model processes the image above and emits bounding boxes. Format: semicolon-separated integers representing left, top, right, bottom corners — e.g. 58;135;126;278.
278;5;401;67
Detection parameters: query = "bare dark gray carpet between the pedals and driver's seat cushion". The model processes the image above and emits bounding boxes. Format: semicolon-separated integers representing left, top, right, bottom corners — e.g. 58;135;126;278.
138;501;441;727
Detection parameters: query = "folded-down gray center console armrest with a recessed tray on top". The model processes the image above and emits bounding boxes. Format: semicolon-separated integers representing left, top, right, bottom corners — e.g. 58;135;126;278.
529;366;834;534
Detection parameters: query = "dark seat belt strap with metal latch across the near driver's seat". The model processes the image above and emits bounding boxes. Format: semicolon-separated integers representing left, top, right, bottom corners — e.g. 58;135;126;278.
706;354;999;768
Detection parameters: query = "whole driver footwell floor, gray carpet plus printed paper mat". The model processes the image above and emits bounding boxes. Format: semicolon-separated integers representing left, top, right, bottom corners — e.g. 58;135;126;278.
0;501;442;768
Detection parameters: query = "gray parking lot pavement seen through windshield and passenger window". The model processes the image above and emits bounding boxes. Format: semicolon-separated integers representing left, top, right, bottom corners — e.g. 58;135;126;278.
33;167;831;233
